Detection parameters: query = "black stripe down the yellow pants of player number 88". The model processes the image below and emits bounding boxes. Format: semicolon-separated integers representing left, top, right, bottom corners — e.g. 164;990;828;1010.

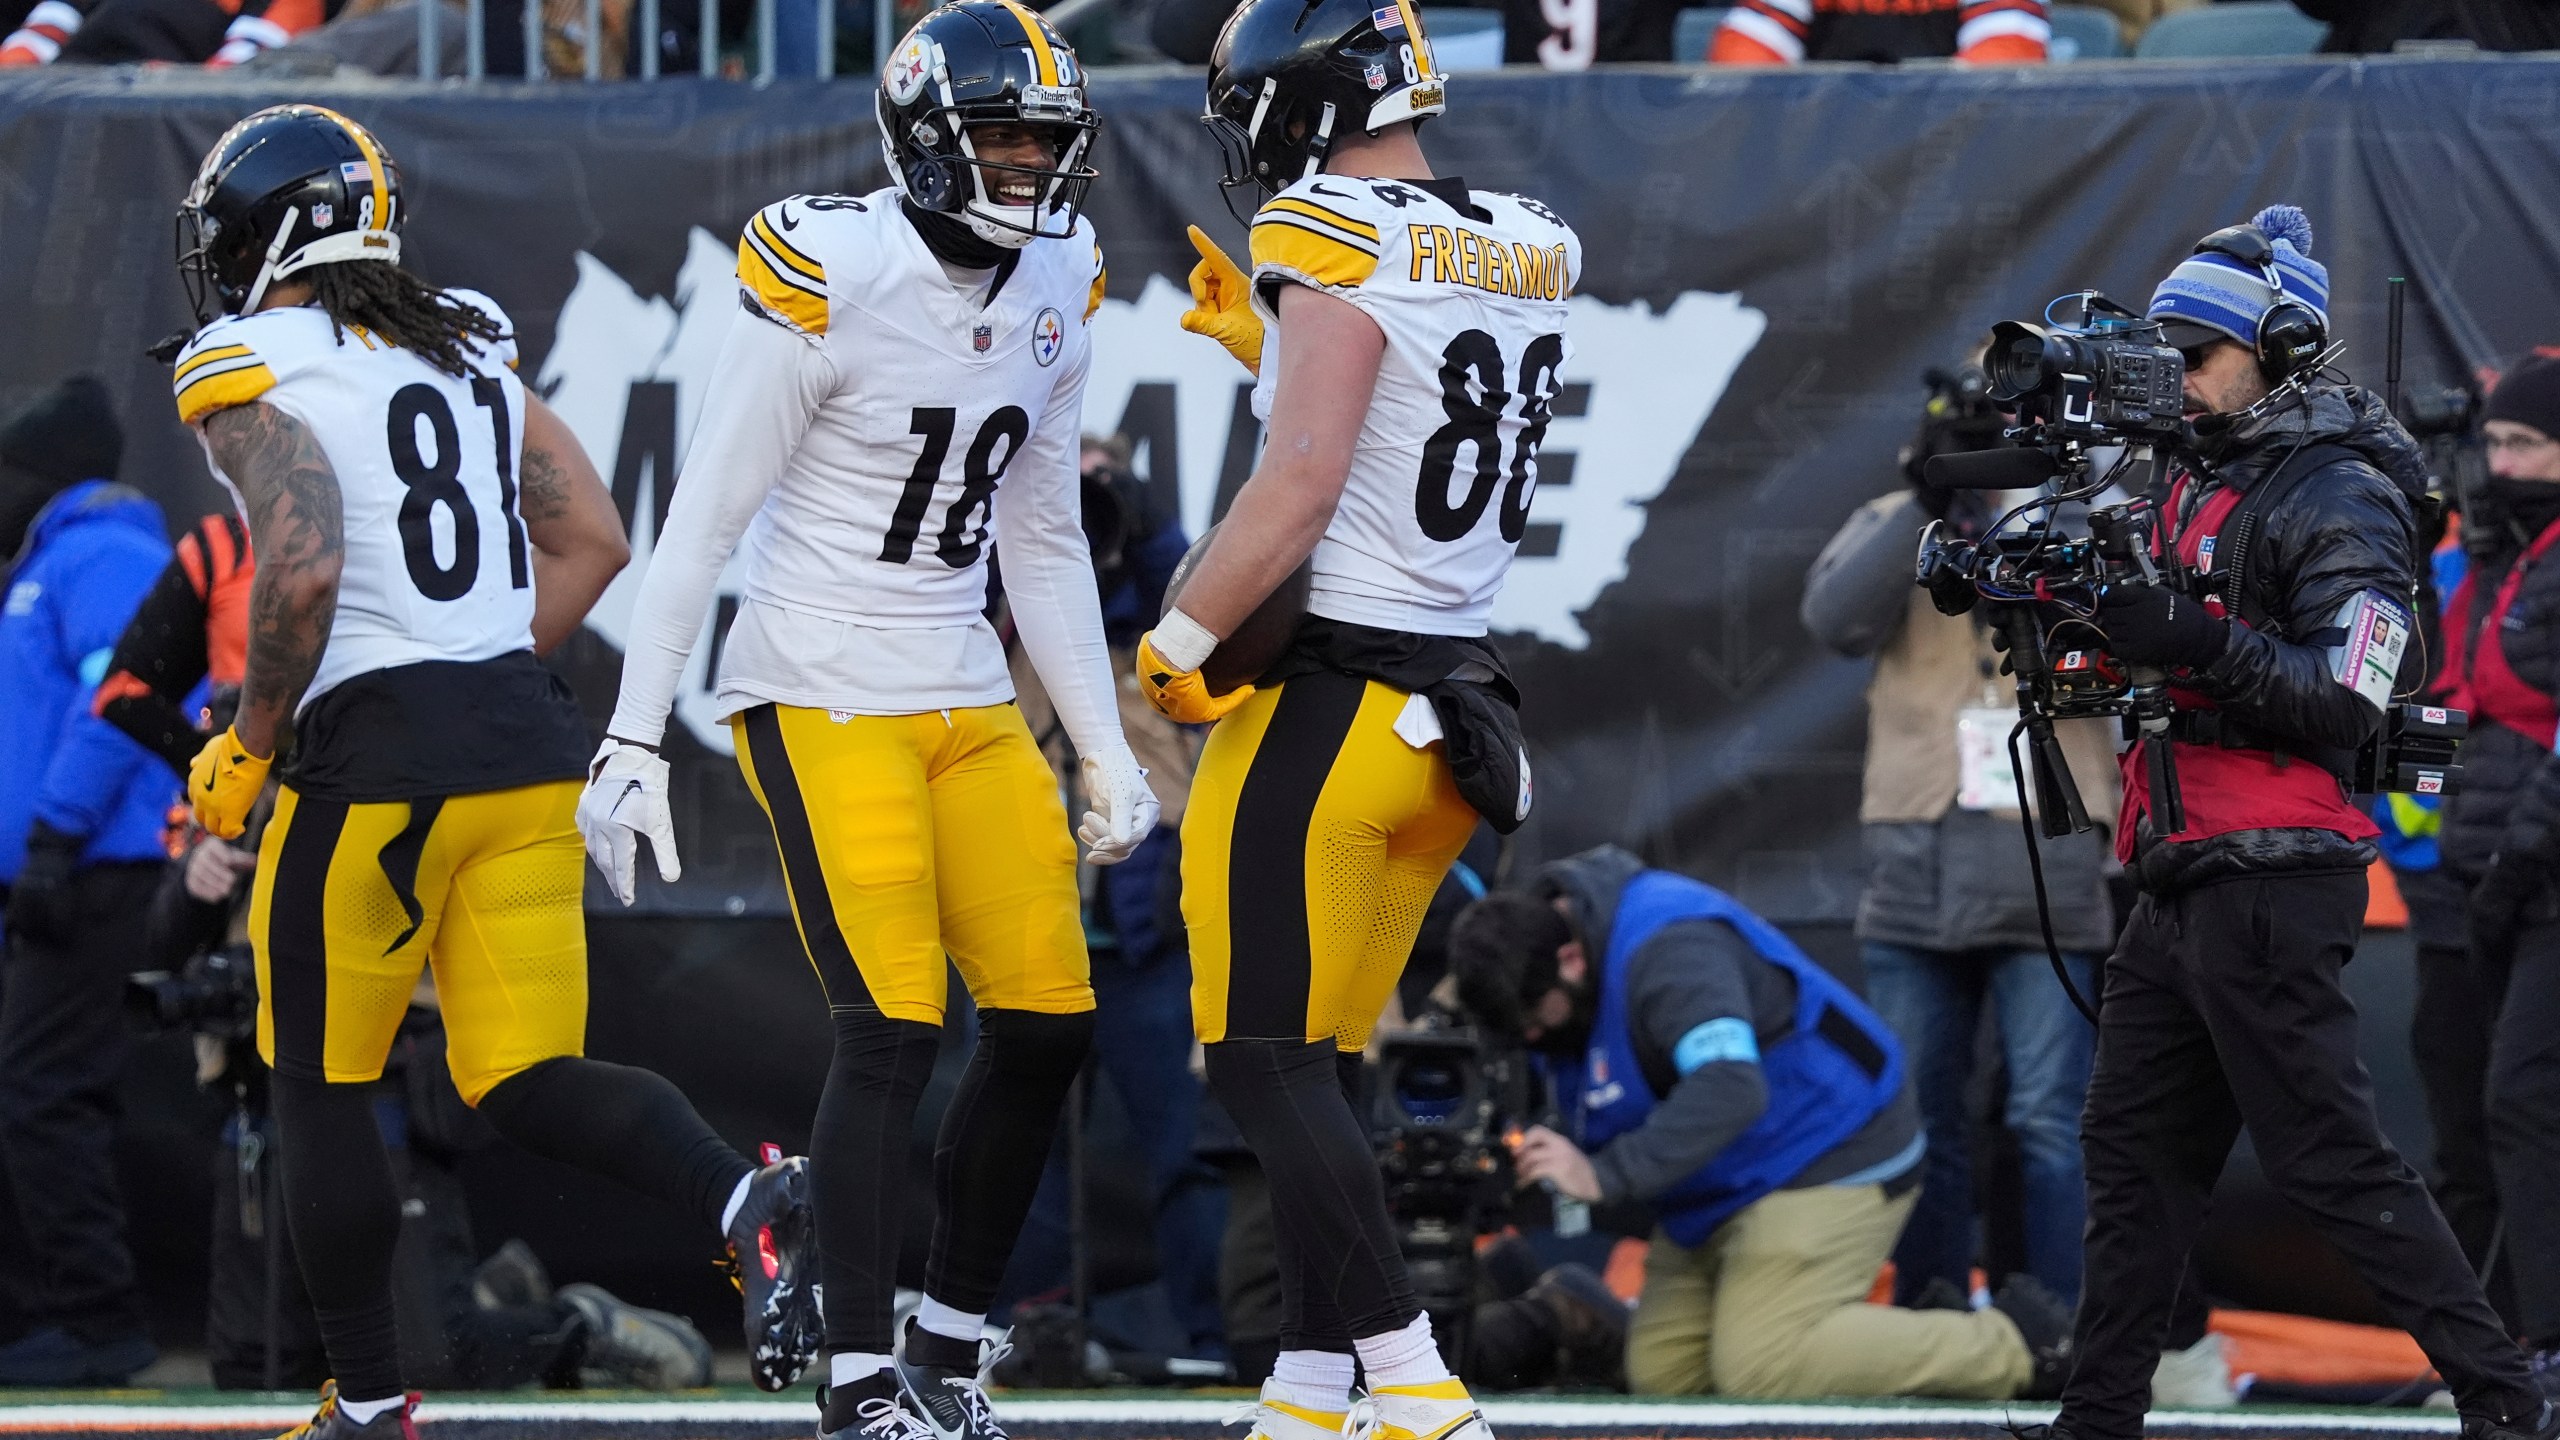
1226;671;1367;1040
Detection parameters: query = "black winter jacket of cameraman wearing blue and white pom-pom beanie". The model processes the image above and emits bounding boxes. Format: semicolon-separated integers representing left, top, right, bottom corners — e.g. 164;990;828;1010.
2135;384;2427;894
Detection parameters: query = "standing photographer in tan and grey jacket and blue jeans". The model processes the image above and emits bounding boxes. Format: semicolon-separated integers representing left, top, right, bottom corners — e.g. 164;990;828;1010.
1802;364;2117;1307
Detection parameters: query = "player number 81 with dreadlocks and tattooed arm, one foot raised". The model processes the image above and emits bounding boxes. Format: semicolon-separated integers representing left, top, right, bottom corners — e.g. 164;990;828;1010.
177;105;817;1440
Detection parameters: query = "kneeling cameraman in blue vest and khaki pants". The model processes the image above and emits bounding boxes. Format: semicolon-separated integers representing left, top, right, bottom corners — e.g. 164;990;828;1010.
1449;846;2068;1399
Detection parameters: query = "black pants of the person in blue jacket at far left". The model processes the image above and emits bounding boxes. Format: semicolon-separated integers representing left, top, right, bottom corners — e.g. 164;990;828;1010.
0;863;164;1343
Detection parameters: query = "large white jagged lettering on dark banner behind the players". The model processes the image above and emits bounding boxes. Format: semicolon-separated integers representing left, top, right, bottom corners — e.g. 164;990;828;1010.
535;228;1769;753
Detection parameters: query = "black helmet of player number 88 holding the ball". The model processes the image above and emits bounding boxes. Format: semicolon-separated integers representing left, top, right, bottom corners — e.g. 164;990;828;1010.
1201;0;1449;195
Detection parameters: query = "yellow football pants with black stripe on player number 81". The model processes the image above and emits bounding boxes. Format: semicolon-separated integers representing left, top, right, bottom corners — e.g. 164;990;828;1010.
248;779;586;1104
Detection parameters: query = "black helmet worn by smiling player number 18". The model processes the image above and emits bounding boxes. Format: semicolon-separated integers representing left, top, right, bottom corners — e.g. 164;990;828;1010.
878;0;1101;249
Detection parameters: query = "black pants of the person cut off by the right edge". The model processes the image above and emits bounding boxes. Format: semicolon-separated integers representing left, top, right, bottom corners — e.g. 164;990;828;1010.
2481;922;2560;1348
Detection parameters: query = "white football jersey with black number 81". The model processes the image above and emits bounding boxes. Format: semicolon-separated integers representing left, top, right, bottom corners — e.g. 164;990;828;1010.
174;290;532;710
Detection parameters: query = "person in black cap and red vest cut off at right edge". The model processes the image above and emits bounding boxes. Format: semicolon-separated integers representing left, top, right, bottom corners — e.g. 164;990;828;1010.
2440;356;2560;1371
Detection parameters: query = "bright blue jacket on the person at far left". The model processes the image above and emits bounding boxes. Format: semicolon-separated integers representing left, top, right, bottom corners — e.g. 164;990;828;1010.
0;479;182;884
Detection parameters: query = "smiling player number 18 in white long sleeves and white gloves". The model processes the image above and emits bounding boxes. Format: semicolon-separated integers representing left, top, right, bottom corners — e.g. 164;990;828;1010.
579;0;1157;1440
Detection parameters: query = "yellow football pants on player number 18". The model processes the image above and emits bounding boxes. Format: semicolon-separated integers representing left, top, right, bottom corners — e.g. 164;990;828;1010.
730;705;1093;1025
